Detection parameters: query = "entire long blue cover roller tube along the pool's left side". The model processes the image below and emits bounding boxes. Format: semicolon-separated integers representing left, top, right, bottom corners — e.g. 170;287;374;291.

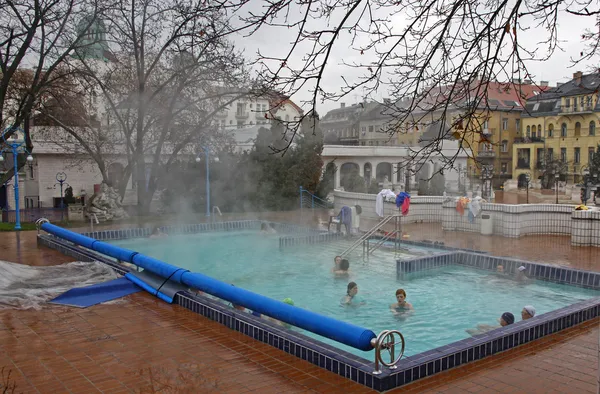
41;223;375;351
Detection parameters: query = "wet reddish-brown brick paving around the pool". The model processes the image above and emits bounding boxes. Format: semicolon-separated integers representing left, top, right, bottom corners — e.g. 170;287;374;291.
0;217;600;393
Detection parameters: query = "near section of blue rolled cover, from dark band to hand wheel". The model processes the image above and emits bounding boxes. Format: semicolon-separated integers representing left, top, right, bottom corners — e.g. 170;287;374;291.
181;272;375;351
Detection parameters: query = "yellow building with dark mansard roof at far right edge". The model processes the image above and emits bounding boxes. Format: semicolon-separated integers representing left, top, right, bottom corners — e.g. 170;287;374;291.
512;71;600;185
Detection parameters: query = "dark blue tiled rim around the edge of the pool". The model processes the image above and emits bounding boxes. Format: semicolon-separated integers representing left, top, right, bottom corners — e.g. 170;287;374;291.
38;235;600;391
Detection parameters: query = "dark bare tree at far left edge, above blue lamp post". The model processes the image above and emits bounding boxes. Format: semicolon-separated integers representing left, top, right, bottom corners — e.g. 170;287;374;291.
0;0;104;183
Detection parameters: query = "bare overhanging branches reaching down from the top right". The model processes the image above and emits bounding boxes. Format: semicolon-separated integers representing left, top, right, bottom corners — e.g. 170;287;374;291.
233;0;600;169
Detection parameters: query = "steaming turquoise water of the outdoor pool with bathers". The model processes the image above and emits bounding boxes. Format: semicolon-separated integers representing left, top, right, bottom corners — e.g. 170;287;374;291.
113;232;600;359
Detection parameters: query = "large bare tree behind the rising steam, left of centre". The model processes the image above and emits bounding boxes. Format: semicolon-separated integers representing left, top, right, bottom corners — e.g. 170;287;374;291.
37;0;255;212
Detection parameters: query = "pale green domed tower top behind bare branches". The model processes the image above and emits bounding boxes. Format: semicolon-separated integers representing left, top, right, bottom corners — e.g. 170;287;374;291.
73;16;112;62
